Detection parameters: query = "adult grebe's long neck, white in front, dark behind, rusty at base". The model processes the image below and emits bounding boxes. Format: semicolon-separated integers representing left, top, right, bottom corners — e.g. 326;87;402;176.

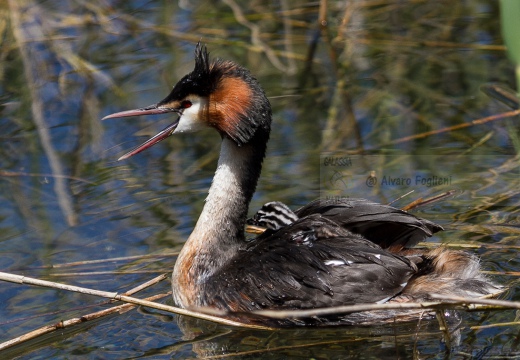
172;138;265;307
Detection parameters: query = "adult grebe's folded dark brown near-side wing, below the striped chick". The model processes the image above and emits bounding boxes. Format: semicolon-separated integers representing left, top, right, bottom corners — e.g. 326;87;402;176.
203;214;417;311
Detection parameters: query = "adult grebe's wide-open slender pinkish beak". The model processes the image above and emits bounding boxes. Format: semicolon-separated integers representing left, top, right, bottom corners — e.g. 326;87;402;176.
101;104;180;161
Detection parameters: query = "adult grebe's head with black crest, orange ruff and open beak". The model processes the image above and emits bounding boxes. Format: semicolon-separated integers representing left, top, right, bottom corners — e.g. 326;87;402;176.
103;43;271;160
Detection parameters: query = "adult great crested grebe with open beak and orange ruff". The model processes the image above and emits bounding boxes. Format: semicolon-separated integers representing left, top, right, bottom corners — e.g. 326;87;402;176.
104;44;497;326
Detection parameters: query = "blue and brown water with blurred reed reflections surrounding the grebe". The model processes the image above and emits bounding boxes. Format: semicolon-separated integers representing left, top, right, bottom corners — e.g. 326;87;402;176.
0;0;520;358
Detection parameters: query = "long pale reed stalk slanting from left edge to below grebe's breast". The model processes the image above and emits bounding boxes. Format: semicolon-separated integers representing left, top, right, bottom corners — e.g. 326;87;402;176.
0;272;272;330
